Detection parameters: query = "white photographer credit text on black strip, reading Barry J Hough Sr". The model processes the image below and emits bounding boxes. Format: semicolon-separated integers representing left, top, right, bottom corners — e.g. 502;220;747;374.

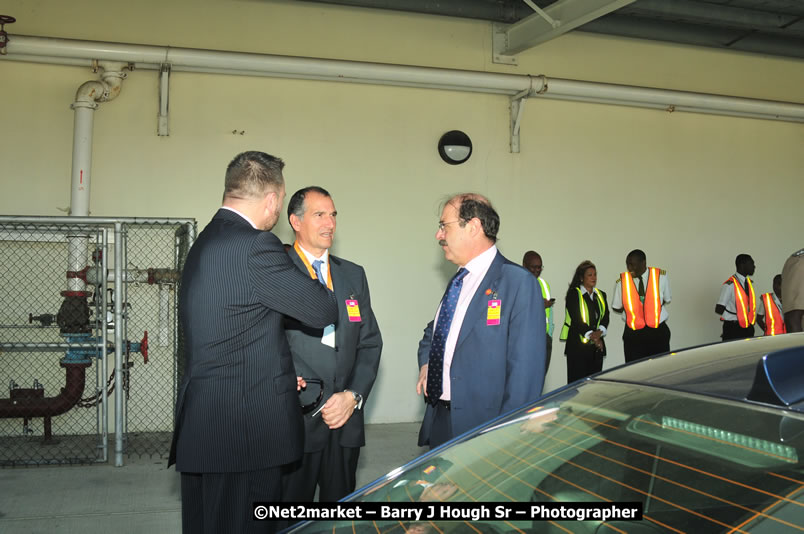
252;502;642;521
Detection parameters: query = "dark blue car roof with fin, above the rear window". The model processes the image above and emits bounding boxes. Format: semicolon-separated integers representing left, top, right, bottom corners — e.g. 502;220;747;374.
594;333;804;412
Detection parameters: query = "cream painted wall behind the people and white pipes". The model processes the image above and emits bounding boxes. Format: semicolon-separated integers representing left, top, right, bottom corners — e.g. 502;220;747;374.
0;0;804;428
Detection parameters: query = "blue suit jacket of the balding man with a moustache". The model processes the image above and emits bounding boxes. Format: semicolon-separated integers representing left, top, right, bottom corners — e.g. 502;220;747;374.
418;252;546;445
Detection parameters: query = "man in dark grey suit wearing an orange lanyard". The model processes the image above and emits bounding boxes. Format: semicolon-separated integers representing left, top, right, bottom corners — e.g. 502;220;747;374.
282;186;382;502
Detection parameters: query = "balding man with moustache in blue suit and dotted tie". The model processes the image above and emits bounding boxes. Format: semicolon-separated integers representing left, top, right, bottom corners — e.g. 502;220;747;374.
416;193;546;448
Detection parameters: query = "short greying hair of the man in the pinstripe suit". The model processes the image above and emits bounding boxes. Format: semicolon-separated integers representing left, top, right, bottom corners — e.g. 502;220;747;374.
223;150;285;200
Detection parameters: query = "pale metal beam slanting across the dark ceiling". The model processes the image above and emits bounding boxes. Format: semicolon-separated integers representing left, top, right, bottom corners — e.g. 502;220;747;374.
493;0;635;56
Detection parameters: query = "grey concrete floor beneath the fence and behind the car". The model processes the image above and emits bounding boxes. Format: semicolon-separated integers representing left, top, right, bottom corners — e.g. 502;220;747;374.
0;423;427;534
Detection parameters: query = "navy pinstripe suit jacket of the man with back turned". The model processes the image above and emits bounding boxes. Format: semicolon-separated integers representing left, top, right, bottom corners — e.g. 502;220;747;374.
169;209;338;473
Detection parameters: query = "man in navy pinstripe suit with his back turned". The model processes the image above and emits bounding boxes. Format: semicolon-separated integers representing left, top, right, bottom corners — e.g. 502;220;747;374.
169;152;338;533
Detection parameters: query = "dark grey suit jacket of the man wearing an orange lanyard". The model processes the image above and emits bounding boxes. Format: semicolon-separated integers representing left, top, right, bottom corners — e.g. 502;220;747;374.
285;249;382;452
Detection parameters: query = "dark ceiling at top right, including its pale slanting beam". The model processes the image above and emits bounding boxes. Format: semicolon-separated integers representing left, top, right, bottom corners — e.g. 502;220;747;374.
296;0;804;59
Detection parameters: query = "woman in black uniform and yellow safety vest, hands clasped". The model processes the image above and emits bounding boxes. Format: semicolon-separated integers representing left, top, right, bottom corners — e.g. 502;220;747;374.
561;260;609;383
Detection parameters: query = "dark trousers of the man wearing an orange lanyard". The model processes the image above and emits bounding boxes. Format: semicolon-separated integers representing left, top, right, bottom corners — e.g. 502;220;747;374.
282;428;360;502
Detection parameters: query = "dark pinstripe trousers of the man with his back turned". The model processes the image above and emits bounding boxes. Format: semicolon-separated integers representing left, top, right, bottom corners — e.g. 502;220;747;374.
181;467;282;534
